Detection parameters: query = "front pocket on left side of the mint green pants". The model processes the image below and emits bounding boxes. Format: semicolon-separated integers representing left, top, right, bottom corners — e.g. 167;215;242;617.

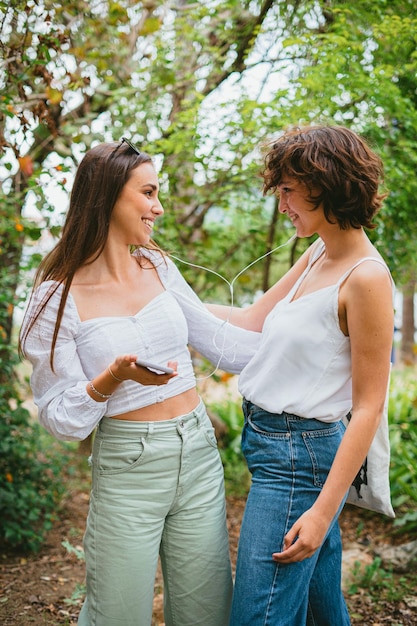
97;440;145;476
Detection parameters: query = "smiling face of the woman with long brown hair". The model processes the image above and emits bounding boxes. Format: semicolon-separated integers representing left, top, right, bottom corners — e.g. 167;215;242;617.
109;163;164;246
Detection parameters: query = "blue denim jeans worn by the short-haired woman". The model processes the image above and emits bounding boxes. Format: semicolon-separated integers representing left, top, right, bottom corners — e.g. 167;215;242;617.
230;400;350;626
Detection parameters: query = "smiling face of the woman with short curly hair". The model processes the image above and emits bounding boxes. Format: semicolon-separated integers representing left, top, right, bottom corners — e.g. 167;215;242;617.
277;177;325;237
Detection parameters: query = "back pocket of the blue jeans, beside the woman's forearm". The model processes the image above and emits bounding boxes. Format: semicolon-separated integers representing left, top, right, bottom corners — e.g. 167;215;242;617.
303;426;340;488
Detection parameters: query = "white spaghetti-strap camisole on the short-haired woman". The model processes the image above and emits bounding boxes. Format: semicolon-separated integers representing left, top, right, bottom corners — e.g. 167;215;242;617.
239;240;389;422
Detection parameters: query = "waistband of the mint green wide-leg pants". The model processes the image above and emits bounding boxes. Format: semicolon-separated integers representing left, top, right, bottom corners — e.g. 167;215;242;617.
99;400;207;437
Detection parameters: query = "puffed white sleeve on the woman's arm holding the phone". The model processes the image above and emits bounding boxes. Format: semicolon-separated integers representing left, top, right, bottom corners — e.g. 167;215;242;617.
23;282;107;441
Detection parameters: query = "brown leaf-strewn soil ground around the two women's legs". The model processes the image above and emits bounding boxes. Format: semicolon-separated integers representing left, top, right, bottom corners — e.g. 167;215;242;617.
0;490;417;626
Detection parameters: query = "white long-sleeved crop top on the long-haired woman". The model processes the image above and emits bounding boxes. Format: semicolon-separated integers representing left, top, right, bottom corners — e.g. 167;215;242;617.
24;250;260;440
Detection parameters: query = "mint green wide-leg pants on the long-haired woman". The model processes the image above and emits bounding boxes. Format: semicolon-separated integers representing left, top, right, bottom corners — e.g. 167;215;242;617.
78;402;232;626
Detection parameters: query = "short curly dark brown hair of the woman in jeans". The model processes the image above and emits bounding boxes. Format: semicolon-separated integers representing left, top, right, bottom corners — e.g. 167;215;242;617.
262;125;387;229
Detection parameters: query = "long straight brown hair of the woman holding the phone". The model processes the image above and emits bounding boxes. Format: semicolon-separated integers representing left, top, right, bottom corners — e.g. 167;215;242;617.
19;141;159;369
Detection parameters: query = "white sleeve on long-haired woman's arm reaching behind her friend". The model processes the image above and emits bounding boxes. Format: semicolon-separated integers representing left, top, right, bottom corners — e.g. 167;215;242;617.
157;254;261;374
